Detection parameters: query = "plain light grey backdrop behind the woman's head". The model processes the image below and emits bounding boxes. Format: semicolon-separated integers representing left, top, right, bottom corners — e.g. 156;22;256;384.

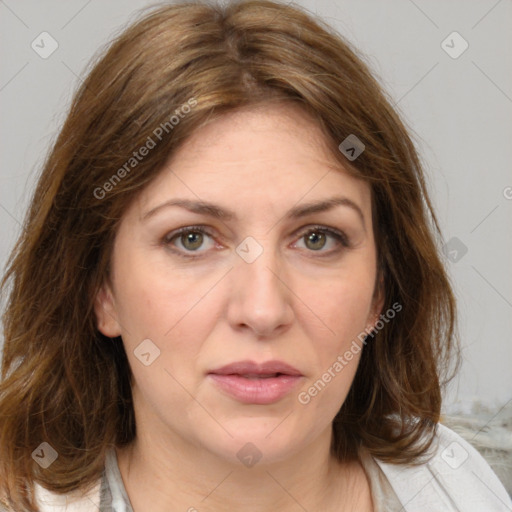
0;0;512;417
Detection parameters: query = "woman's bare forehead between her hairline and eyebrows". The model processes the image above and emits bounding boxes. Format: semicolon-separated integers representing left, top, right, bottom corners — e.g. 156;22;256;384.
134;105;370;221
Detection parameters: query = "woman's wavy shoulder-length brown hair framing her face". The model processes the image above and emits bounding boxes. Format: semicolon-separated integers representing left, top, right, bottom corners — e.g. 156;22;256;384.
0;0;459;511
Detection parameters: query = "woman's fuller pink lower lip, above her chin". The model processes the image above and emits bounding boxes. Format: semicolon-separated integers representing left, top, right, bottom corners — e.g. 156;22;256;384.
209;373;302;405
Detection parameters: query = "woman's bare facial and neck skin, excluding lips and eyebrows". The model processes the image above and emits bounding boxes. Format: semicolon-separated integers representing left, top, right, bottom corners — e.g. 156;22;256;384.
95;105;382;512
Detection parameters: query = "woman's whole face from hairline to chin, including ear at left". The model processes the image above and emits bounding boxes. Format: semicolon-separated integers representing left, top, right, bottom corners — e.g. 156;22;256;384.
96;106;382;463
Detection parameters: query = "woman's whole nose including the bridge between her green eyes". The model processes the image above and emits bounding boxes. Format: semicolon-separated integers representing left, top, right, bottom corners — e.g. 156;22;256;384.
230;239;293;335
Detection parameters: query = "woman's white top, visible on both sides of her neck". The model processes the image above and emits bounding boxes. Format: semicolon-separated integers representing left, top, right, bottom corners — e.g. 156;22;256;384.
31;424;512;512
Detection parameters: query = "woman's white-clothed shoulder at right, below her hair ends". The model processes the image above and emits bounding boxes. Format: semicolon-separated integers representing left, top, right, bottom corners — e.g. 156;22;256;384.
375;423;512;512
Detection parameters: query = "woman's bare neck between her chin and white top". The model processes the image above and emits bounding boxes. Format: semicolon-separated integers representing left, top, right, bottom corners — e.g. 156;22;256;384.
117;429;371;512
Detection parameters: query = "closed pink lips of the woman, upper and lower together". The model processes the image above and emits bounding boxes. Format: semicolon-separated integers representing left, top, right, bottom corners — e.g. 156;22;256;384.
208;361;302;405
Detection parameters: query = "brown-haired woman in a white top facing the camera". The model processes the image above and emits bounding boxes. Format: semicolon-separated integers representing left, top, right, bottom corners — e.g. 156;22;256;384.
0;0;510;512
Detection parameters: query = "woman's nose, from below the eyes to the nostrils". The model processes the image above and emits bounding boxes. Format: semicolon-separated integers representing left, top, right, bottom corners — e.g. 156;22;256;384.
227;245;294;338
